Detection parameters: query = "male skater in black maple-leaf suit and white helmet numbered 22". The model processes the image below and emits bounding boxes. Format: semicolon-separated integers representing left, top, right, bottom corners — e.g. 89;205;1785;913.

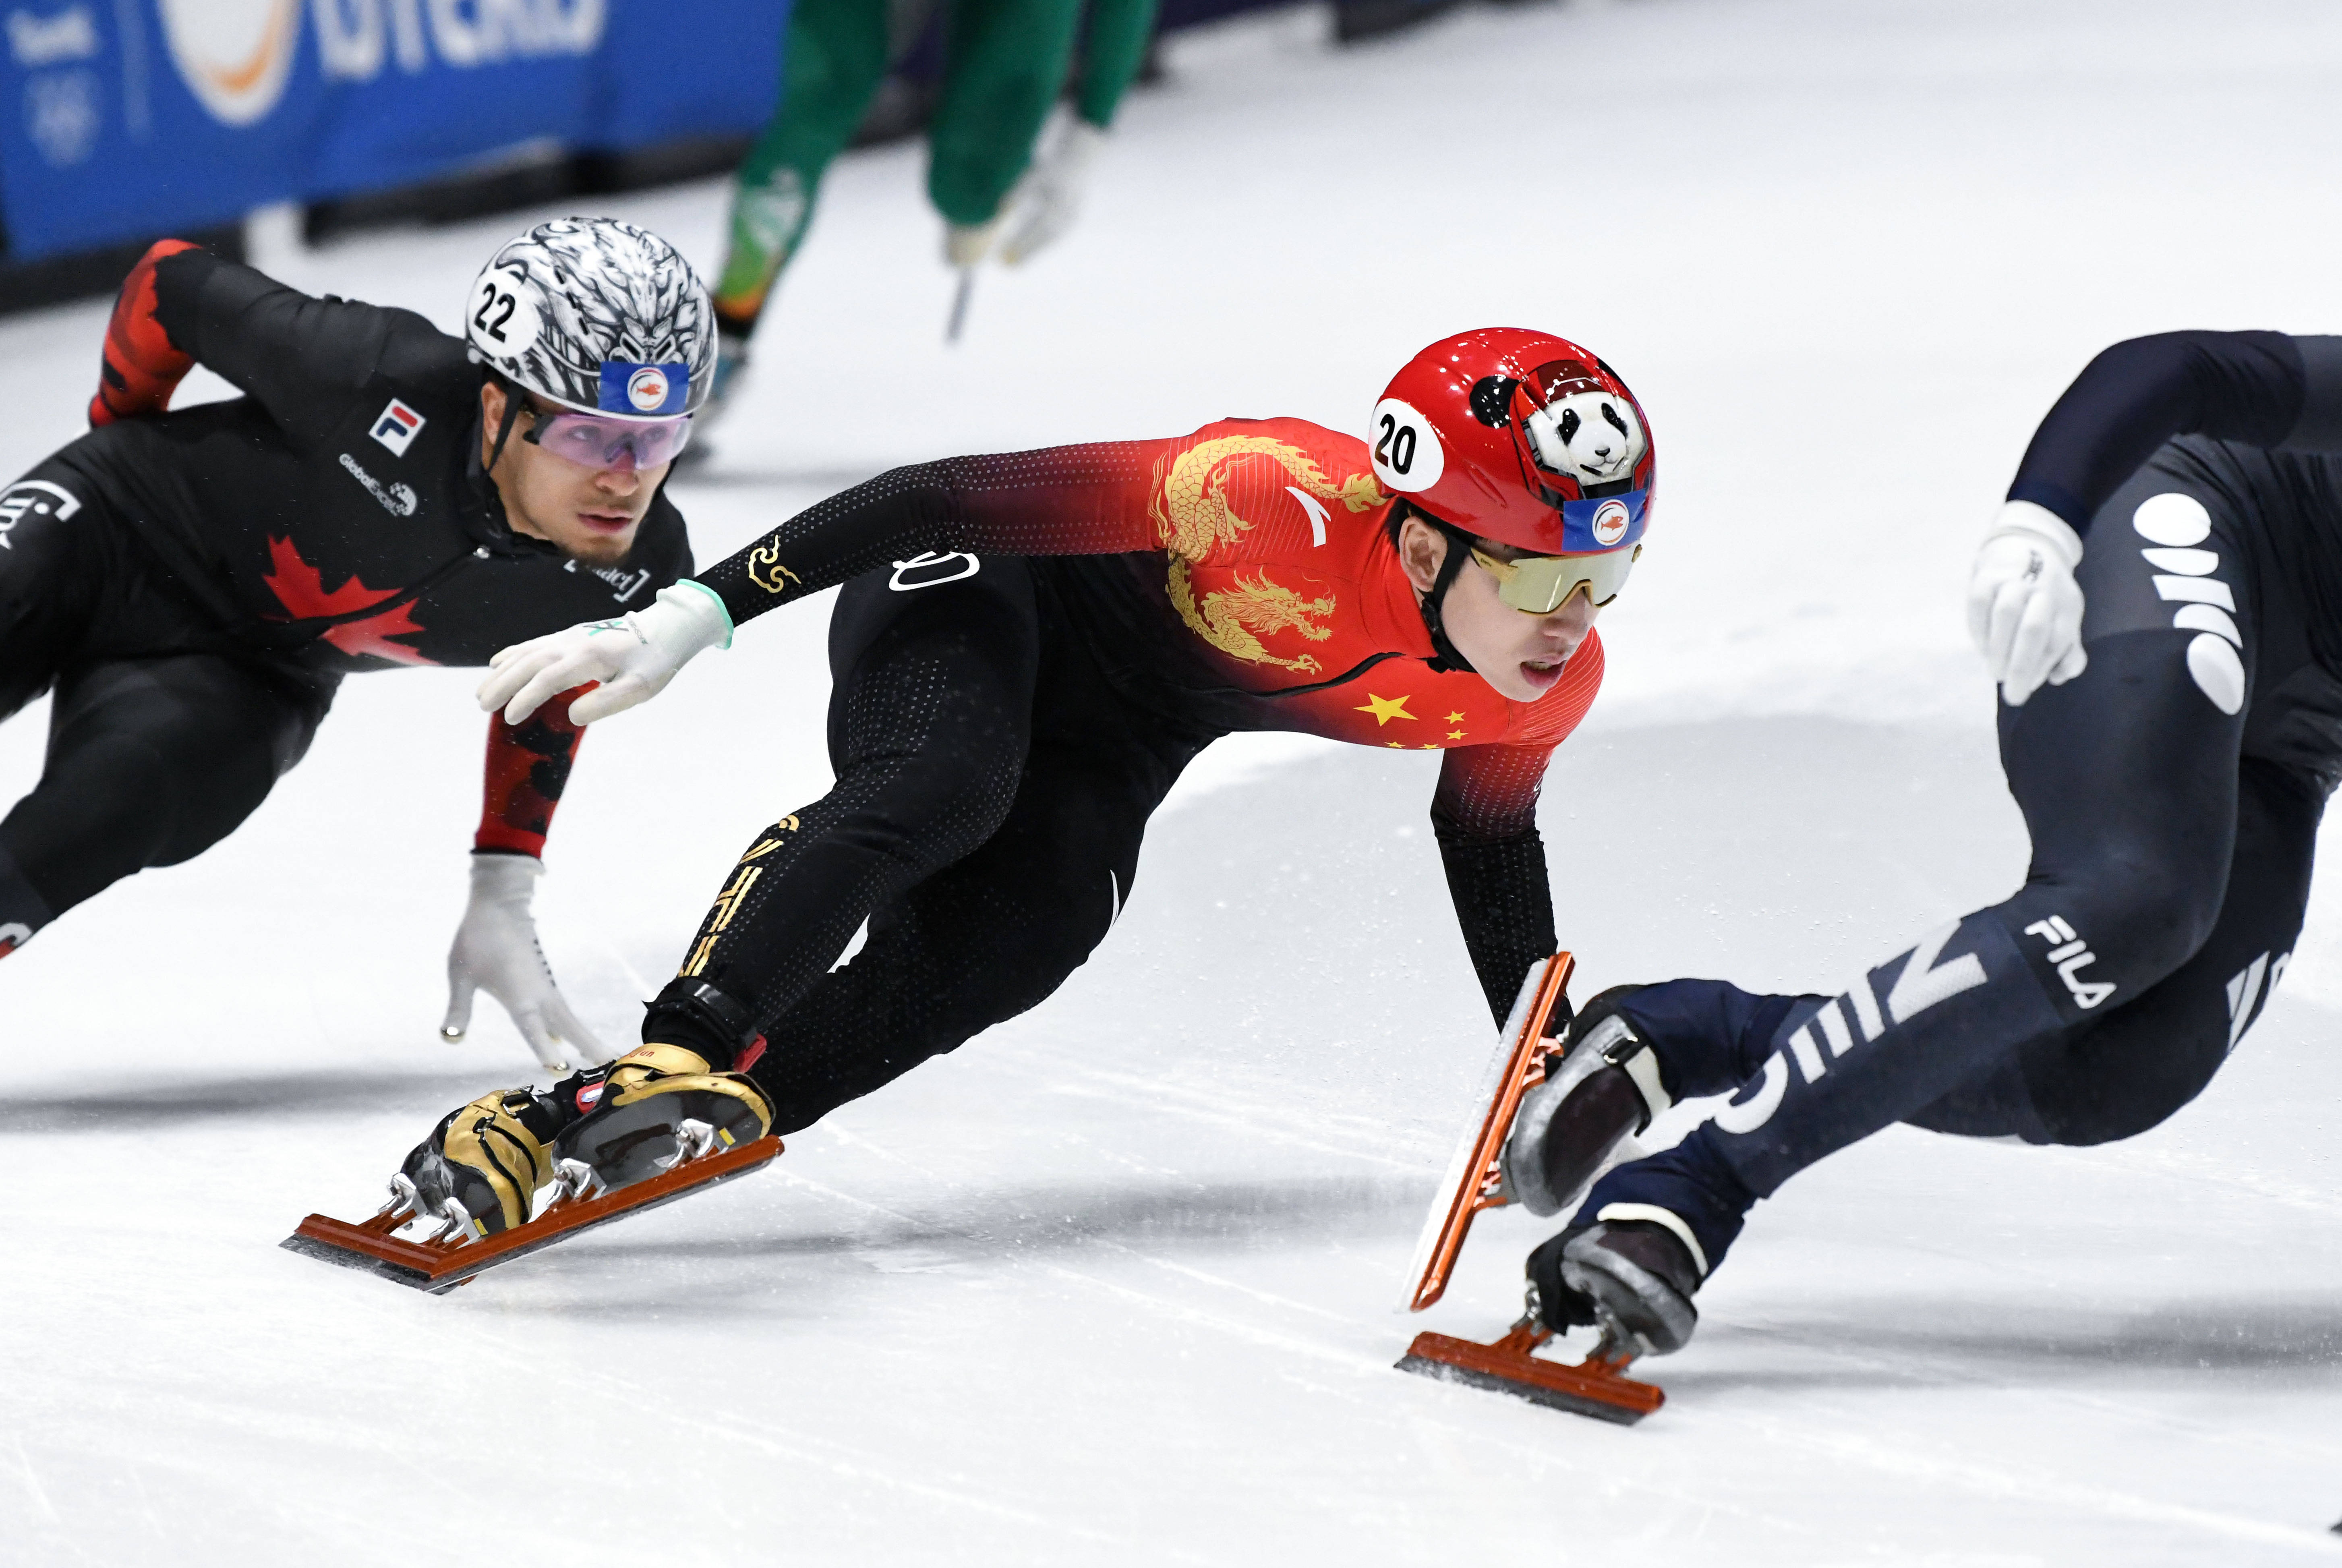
0;220;714;1067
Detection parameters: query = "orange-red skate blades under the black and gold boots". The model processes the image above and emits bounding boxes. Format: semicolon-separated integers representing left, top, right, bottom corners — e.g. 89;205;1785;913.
279;1137;780;1296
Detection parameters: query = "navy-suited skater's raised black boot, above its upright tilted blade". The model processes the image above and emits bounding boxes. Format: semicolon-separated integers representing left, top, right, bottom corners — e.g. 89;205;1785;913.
1503;984;1675;1216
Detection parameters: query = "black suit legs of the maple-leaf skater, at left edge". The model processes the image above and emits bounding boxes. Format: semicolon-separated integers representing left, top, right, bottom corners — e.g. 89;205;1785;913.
0;464;335;954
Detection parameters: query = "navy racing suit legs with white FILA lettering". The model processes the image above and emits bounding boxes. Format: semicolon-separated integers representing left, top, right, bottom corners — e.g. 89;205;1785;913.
1578;441;2342;1266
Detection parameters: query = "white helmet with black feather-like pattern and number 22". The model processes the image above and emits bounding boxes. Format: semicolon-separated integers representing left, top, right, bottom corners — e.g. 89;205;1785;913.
464;218;716;420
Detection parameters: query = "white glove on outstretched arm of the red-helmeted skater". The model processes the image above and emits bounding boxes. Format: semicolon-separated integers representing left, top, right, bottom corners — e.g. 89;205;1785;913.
480;577;731;724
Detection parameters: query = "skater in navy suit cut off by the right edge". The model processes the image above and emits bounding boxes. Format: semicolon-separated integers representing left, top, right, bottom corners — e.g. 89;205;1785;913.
1503;333;2342;1353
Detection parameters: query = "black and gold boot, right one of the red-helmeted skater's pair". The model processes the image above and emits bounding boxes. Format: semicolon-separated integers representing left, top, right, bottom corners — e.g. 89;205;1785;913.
553;1043;773;1193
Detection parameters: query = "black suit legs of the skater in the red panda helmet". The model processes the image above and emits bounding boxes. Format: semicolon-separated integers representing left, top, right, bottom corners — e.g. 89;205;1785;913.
644;558;1213;1132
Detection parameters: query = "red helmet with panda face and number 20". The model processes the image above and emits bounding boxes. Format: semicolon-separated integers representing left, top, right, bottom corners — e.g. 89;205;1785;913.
1368;326;1658;555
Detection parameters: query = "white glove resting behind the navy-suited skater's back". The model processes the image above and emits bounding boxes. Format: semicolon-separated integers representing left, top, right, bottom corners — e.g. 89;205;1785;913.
1967;501;2089;708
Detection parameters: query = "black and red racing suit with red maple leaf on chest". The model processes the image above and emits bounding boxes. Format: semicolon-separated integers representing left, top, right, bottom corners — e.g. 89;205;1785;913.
0;241;691;954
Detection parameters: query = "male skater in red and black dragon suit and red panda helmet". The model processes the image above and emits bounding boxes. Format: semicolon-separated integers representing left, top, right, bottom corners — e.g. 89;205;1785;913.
384;330;1656;1235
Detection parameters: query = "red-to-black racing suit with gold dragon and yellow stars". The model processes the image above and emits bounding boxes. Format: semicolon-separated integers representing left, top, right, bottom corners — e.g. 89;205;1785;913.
644;420;1602;1132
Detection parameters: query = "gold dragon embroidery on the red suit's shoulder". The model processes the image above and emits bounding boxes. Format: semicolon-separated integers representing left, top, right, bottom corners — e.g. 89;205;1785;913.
1150;436;1391;675
